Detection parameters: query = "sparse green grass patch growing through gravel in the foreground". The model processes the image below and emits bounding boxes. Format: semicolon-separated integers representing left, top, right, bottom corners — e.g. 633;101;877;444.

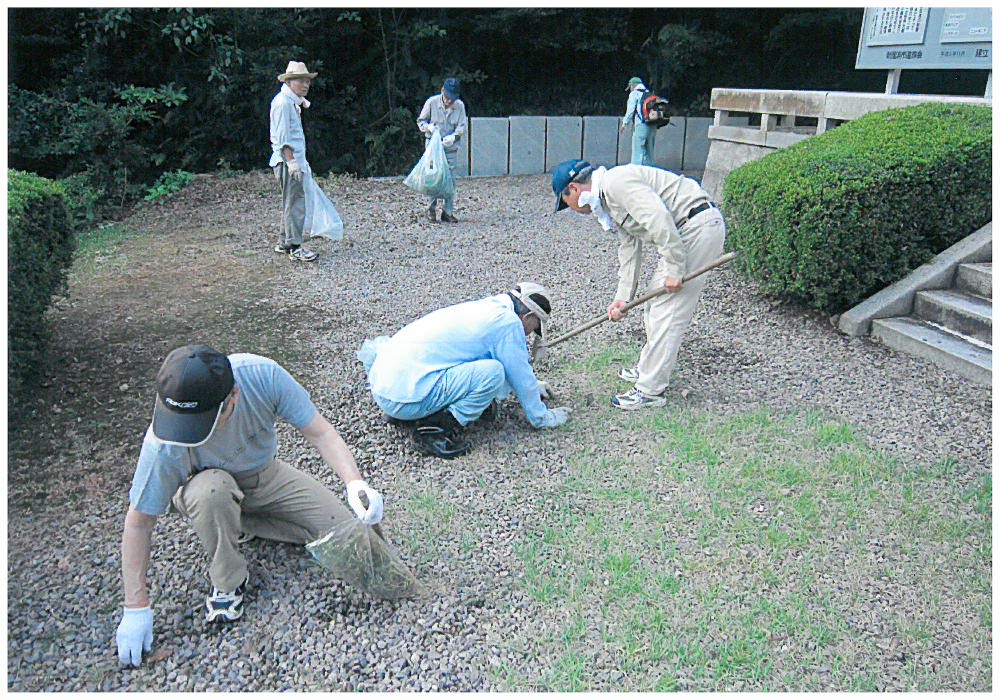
505;342;992;691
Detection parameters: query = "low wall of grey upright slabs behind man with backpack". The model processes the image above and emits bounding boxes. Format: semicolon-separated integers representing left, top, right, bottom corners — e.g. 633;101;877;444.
455;116;712;177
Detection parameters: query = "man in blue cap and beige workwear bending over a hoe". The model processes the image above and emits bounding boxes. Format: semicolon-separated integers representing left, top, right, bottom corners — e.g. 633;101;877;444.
552;160;726;410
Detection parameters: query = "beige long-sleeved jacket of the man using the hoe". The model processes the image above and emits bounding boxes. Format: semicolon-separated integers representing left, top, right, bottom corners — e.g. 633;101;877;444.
600;165;709;301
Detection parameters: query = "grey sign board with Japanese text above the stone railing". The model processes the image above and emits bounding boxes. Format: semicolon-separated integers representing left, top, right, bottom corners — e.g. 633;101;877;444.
854;7;993;70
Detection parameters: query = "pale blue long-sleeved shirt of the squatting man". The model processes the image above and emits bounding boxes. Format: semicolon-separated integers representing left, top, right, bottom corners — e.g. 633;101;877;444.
368;294;552;428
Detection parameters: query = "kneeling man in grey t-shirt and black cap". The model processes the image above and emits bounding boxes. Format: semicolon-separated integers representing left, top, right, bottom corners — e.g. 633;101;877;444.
117;345;382;666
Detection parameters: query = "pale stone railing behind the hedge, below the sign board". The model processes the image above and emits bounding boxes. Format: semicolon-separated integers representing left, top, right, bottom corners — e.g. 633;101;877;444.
703;88;993;199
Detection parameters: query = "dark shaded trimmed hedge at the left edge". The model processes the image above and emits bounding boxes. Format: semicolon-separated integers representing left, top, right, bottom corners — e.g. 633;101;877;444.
7;170;76;401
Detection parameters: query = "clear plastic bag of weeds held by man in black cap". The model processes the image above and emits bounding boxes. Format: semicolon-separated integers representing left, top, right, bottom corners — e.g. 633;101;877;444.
306;518;424;600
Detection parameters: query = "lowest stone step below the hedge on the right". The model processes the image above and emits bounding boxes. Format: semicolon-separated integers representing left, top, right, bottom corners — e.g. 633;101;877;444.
872;316;993;386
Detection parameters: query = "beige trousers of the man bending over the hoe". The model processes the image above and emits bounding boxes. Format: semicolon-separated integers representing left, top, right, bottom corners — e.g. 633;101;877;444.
635;209;726;396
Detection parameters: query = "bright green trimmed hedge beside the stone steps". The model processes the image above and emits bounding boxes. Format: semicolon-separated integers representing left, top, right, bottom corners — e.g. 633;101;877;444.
724;104;993;313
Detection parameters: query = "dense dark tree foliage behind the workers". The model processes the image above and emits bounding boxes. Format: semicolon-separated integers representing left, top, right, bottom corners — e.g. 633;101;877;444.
8;8;985;213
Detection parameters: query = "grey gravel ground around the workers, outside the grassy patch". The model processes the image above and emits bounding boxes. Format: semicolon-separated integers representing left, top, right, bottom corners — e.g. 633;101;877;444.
8;174;992;691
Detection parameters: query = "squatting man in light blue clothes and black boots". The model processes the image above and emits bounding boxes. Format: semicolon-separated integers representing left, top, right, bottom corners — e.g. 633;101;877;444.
358;282;571;458
